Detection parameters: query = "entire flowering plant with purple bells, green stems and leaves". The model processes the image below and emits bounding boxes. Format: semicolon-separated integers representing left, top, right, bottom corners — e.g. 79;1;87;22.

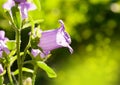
0;0;73;85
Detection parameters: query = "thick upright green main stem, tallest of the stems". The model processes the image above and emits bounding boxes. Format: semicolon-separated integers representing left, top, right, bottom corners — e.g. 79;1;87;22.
16;29;23;85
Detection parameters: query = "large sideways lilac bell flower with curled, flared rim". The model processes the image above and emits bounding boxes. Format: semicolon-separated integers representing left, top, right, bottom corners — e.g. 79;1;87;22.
38;20;73;55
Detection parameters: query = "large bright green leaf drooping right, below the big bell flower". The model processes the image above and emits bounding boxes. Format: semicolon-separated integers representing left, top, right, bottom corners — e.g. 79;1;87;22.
37;61;57;78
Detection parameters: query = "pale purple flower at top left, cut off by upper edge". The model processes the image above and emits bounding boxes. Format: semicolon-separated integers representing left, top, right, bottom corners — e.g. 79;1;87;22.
3;0;36;20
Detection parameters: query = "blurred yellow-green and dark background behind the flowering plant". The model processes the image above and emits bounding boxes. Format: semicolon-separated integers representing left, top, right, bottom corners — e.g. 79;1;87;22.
0;0;120;85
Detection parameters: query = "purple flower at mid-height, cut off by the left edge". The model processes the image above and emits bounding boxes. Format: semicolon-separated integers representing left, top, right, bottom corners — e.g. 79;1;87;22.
0;31;10;58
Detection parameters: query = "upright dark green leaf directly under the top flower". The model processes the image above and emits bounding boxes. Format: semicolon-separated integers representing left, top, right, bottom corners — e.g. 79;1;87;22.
11;6;22;29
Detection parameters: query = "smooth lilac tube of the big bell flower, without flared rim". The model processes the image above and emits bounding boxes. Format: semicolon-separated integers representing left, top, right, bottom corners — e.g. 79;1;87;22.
38;29;60;51
